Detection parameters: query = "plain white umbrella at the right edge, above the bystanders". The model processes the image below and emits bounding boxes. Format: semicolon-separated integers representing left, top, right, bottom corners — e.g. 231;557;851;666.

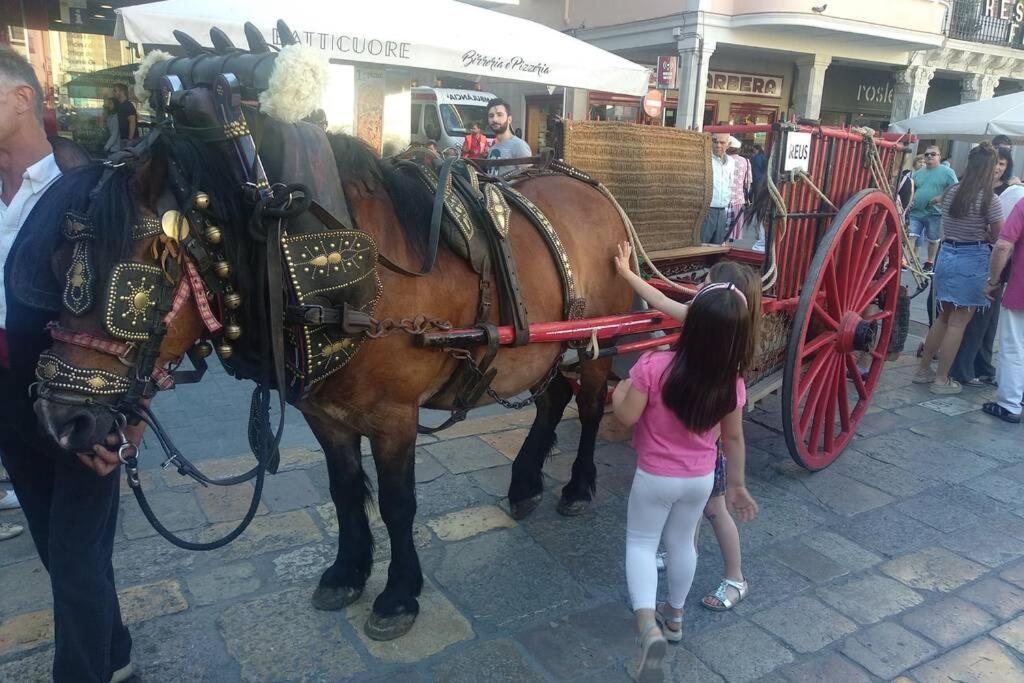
889;92;1024;142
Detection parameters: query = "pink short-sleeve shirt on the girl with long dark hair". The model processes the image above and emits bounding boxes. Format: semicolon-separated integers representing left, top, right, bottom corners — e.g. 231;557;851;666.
630;351;746;477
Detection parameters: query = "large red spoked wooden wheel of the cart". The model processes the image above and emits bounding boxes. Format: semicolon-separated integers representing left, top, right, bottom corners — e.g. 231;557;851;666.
782;189;901;470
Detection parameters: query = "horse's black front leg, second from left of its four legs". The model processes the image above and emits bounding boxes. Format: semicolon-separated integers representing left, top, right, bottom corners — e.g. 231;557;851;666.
365;419;423;640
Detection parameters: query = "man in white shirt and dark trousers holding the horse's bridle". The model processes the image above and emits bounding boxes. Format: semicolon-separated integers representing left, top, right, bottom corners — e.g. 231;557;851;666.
0;46;134;683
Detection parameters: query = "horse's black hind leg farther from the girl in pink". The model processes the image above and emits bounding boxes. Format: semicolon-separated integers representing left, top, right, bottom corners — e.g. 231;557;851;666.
509;374;572;519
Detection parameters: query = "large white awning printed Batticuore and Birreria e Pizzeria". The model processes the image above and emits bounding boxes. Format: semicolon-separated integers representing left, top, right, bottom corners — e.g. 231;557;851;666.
114;0;648;95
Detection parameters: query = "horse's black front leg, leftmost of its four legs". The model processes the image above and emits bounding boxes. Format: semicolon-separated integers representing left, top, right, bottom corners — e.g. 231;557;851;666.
306;416;374;609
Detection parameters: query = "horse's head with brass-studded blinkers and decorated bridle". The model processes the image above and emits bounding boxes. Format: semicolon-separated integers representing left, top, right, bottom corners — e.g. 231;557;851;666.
35;20;323;452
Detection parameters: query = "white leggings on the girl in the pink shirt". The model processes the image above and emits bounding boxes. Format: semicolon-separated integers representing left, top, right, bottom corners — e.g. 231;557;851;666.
626;469;715;610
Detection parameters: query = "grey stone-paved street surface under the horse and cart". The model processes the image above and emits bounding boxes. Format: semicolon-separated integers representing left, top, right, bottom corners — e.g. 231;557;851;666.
0;329;1024;682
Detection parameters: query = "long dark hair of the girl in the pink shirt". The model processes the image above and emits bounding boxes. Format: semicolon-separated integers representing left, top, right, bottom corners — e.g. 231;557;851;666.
662;288;751;433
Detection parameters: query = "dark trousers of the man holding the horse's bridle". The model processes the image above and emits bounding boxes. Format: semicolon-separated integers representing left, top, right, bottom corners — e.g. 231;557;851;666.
0;430;131;683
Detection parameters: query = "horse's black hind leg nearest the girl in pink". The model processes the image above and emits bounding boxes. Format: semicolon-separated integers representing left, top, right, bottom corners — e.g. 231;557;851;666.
557;358;611;516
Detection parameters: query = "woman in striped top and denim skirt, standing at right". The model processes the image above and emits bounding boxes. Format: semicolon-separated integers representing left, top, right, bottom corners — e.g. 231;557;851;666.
913;142;1002;394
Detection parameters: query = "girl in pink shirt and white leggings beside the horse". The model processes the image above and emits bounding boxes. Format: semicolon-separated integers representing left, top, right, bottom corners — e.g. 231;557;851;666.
612;270;757;681
